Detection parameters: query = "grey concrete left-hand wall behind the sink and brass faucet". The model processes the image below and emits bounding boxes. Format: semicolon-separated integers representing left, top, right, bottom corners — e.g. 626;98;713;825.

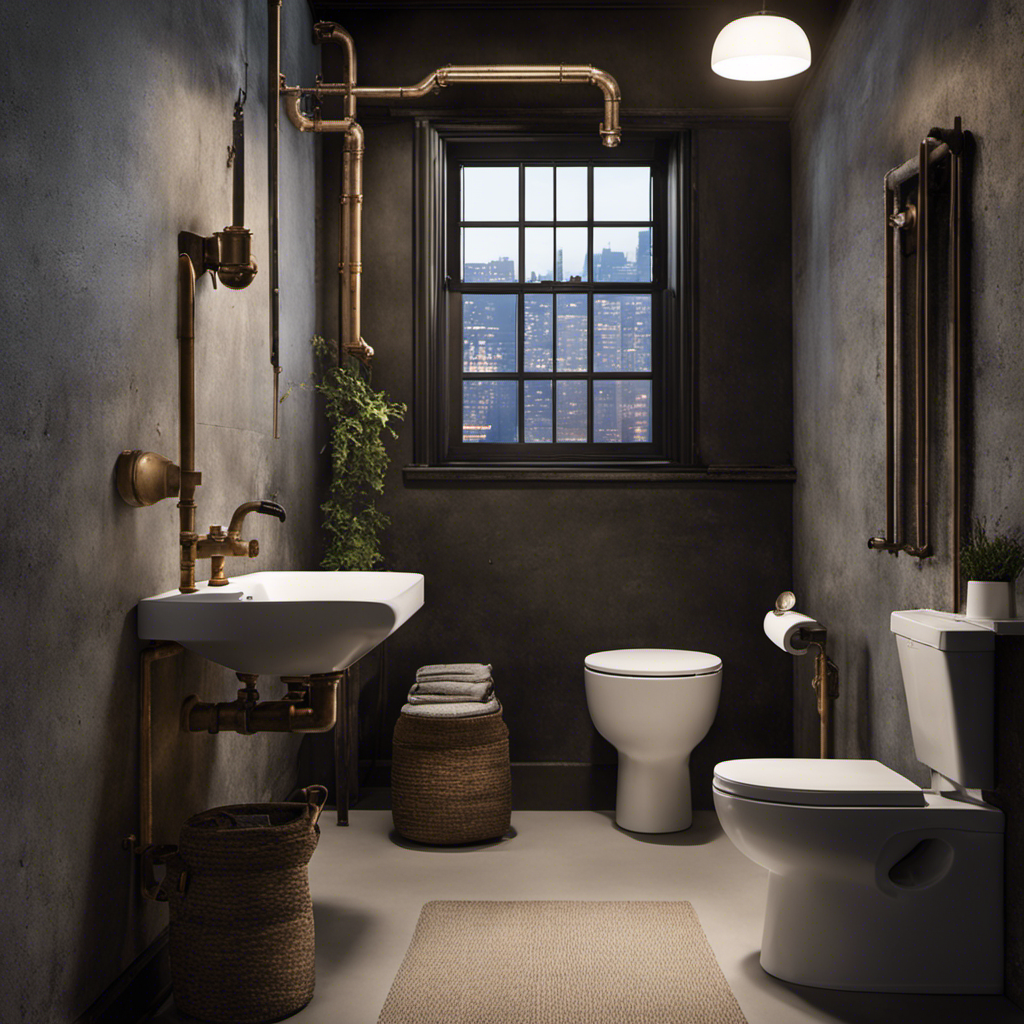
0;0;318;1022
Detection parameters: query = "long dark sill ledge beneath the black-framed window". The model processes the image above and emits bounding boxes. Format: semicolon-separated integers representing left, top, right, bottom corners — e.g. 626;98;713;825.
401;463;797;484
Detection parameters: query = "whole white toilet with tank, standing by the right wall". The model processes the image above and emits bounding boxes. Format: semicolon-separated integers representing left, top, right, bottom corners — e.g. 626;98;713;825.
714;611;1004;992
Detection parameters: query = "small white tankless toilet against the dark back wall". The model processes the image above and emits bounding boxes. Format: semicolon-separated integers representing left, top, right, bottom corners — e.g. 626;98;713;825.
584;648;722;833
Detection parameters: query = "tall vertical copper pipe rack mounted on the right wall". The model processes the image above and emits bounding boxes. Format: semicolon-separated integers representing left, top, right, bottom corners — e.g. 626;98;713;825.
867;118;971;611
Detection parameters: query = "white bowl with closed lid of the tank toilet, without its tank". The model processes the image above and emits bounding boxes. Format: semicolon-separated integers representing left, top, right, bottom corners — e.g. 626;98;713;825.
713;758;1004;992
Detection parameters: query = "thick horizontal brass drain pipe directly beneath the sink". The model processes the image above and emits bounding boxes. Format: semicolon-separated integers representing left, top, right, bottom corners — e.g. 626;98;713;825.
181;672;342;735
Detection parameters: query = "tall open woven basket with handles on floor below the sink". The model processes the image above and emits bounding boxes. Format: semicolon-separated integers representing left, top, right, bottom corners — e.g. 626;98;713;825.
164;785;327;1024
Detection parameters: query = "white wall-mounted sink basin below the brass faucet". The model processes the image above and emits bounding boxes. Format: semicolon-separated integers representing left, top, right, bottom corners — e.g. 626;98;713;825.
138;571;423;676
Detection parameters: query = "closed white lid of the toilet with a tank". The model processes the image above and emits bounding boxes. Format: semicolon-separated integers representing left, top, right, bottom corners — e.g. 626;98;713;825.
715;758;925;807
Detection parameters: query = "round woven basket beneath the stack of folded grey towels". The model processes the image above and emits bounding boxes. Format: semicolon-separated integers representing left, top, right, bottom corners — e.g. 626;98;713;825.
391;711;512;846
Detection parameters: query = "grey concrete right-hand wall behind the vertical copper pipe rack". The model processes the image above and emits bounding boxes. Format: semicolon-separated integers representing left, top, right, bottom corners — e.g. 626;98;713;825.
793;0;1024;1001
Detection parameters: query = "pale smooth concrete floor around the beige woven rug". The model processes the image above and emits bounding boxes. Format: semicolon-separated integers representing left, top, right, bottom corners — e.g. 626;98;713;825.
155;810;1024;1024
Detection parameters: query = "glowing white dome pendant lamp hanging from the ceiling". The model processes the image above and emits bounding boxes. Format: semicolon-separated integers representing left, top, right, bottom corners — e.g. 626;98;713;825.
711;8;811;82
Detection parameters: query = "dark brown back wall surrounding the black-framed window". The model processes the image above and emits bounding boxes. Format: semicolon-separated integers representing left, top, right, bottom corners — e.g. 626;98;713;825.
313;10;792;806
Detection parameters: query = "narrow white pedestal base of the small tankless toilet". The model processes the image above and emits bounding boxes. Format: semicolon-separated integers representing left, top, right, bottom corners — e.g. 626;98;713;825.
615;754;693;833
